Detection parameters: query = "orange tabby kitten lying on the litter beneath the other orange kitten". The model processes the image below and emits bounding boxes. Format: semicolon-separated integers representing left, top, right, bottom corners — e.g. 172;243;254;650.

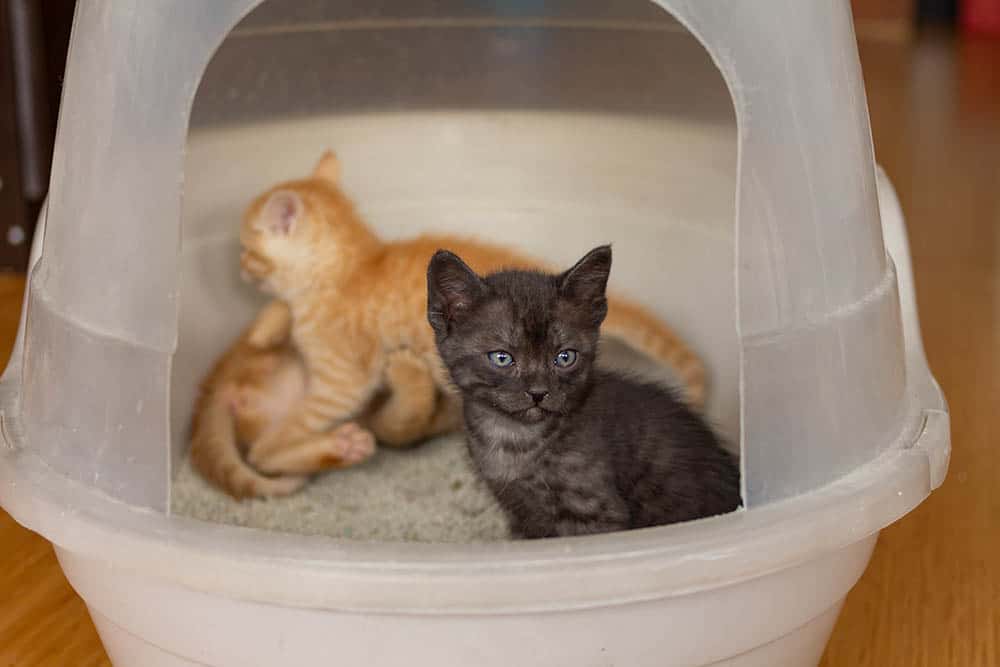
191;301;458;498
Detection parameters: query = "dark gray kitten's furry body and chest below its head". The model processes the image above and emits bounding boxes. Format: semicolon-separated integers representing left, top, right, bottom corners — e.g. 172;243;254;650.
465;373;739;538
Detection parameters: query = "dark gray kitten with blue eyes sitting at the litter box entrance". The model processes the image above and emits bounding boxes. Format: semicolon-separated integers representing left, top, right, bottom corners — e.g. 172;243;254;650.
427;246;740;538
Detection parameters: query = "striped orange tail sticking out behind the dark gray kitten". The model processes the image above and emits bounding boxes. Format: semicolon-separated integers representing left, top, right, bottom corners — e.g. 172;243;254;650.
601;297;707;410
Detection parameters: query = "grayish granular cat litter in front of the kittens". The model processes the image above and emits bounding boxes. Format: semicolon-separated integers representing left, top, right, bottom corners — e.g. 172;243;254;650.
171;435;509;542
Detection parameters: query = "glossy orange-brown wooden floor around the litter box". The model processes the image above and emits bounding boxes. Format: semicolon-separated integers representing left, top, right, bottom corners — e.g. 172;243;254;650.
0;27;1000;667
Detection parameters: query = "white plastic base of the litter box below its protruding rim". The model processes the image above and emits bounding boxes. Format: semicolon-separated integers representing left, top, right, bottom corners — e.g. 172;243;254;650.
57;536;876;667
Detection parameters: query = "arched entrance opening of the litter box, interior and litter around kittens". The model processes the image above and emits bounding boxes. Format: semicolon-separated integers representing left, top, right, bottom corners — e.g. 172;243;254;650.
171;0;740;542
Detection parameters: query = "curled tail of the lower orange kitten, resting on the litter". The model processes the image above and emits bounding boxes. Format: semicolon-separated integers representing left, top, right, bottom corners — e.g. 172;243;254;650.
191;387;306;499
